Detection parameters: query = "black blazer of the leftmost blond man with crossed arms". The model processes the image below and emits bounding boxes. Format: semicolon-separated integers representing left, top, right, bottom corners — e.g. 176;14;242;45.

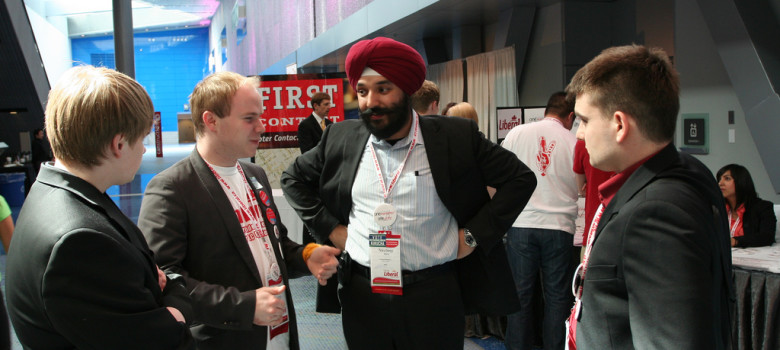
6;165;194;349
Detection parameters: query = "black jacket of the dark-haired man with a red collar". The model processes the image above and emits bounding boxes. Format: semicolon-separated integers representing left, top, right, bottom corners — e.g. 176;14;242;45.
577;144;733;350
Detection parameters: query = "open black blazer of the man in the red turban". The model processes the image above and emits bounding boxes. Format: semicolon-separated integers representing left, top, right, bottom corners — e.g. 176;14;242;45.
281;116;536;315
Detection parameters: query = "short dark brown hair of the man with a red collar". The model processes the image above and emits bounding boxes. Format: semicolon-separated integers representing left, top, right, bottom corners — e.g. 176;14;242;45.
566;45;680;142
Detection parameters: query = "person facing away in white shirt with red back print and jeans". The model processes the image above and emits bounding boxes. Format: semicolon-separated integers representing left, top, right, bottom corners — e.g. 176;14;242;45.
501;92;577;350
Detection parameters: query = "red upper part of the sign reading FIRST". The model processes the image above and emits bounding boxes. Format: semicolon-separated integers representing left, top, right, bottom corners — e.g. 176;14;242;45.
257;74;344;149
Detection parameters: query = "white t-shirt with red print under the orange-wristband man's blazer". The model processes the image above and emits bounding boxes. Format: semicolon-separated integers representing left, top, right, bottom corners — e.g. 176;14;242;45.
209;164;290;350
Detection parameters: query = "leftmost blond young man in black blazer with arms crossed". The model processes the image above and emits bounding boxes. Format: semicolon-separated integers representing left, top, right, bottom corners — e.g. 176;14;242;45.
7;66;194;349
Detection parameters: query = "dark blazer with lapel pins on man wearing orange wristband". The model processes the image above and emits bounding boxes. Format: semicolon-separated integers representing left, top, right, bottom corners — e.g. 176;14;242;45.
138;146;309;349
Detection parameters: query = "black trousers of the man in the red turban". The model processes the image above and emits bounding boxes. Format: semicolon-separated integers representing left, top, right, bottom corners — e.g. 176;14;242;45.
339;269;465;350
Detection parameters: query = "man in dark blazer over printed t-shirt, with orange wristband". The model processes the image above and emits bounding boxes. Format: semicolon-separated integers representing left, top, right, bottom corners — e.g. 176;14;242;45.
138;72;339;350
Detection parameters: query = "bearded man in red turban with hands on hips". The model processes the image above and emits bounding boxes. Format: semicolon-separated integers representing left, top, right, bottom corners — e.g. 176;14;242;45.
281;38;536;349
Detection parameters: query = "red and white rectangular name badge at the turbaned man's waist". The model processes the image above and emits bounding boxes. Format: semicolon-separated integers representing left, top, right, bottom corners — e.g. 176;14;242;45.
368;230;403;295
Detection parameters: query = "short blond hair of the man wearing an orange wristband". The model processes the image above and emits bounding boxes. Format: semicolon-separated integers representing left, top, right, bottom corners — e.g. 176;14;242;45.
190;72;260;135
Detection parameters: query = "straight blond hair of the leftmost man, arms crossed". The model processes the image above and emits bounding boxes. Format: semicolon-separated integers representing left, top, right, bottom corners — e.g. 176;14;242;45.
46;66;154;168
